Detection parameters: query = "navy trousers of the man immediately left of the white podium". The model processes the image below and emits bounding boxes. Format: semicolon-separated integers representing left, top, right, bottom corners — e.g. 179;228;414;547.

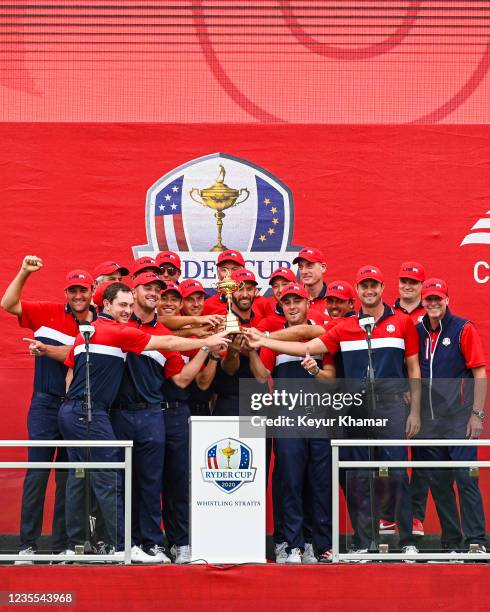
162;402;190;546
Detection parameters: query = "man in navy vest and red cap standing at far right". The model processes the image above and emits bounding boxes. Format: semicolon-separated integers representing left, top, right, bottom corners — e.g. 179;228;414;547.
417;278;486;553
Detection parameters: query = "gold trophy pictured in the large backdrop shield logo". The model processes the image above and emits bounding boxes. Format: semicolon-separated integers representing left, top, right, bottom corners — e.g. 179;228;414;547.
189;164;250;253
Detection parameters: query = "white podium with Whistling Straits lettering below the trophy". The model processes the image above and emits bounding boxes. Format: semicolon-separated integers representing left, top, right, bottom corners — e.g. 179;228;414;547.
190;417;266;563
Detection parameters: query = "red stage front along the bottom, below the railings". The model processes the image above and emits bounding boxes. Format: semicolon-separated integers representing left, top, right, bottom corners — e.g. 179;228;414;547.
0;563;490;612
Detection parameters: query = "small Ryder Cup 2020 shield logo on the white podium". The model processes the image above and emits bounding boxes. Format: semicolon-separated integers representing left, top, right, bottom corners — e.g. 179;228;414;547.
201;438;257;493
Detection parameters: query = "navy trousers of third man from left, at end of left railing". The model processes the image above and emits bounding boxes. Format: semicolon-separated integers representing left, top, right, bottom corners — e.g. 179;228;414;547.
110;404;165;548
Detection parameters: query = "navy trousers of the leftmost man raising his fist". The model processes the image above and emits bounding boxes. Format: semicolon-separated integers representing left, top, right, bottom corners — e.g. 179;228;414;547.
20;392;67;552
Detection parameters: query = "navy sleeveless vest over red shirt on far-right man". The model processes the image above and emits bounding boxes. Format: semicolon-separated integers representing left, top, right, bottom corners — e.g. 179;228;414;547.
417;309;473;417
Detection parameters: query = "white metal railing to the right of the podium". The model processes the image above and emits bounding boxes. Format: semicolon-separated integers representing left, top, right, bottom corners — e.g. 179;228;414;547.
331;439;490;563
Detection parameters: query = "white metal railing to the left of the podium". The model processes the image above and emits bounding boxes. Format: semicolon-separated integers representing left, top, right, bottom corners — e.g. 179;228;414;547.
0;440;133;565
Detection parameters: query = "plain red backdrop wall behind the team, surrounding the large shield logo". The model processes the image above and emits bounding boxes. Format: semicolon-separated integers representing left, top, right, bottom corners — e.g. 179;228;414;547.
0;123;490;532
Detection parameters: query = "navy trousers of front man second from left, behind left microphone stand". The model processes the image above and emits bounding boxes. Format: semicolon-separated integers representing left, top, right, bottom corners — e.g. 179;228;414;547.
59;400;124;550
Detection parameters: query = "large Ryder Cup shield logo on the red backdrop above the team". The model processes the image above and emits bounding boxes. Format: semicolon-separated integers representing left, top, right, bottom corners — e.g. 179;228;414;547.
133;153;300;287
